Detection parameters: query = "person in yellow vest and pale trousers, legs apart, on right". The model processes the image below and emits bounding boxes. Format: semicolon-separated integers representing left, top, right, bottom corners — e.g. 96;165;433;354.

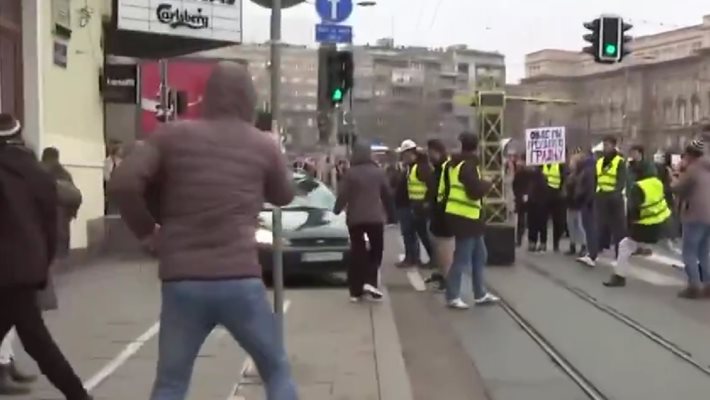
604;164;671;287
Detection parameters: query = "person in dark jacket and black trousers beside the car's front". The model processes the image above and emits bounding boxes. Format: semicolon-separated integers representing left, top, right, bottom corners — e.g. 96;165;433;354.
333;144;394;302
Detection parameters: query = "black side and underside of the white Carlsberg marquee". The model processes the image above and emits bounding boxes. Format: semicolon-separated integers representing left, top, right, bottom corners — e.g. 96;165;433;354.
104;0;234;59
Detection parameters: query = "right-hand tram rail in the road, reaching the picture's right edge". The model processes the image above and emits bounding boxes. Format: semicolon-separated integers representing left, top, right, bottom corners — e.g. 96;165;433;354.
521;261;710;377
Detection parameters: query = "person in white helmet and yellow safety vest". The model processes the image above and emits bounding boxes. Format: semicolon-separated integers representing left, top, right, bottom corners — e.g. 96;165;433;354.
395;140;433;268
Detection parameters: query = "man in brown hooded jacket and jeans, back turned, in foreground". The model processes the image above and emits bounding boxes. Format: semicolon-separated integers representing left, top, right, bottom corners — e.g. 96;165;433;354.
109;62;297;400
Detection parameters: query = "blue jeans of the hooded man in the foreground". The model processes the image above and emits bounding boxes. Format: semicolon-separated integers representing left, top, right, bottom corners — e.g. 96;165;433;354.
150;278;298;400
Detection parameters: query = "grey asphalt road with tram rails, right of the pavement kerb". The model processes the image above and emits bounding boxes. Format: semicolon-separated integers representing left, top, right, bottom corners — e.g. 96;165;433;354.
386;232;710;400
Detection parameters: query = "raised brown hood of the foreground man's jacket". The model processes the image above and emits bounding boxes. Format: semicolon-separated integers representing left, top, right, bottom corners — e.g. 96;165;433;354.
202;62;256;123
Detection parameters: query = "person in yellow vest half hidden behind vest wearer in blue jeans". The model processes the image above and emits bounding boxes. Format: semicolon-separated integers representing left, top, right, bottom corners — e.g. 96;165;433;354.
426;139;454;291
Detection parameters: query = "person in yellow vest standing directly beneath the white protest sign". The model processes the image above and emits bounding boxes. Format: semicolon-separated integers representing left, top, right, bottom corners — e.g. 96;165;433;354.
539;163;567;252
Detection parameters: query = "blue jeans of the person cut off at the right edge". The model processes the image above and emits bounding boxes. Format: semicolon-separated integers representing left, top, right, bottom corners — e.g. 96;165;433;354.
683;223;710;285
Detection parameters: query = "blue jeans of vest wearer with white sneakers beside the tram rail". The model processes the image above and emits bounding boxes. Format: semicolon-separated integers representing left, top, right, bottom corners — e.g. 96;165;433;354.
446;235;488;301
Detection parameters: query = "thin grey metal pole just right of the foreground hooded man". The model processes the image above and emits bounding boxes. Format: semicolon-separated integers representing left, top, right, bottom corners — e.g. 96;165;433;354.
271;0;284;339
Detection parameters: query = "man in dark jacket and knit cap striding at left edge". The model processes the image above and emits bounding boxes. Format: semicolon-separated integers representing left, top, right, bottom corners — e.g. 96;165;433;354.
0;114;91;400
